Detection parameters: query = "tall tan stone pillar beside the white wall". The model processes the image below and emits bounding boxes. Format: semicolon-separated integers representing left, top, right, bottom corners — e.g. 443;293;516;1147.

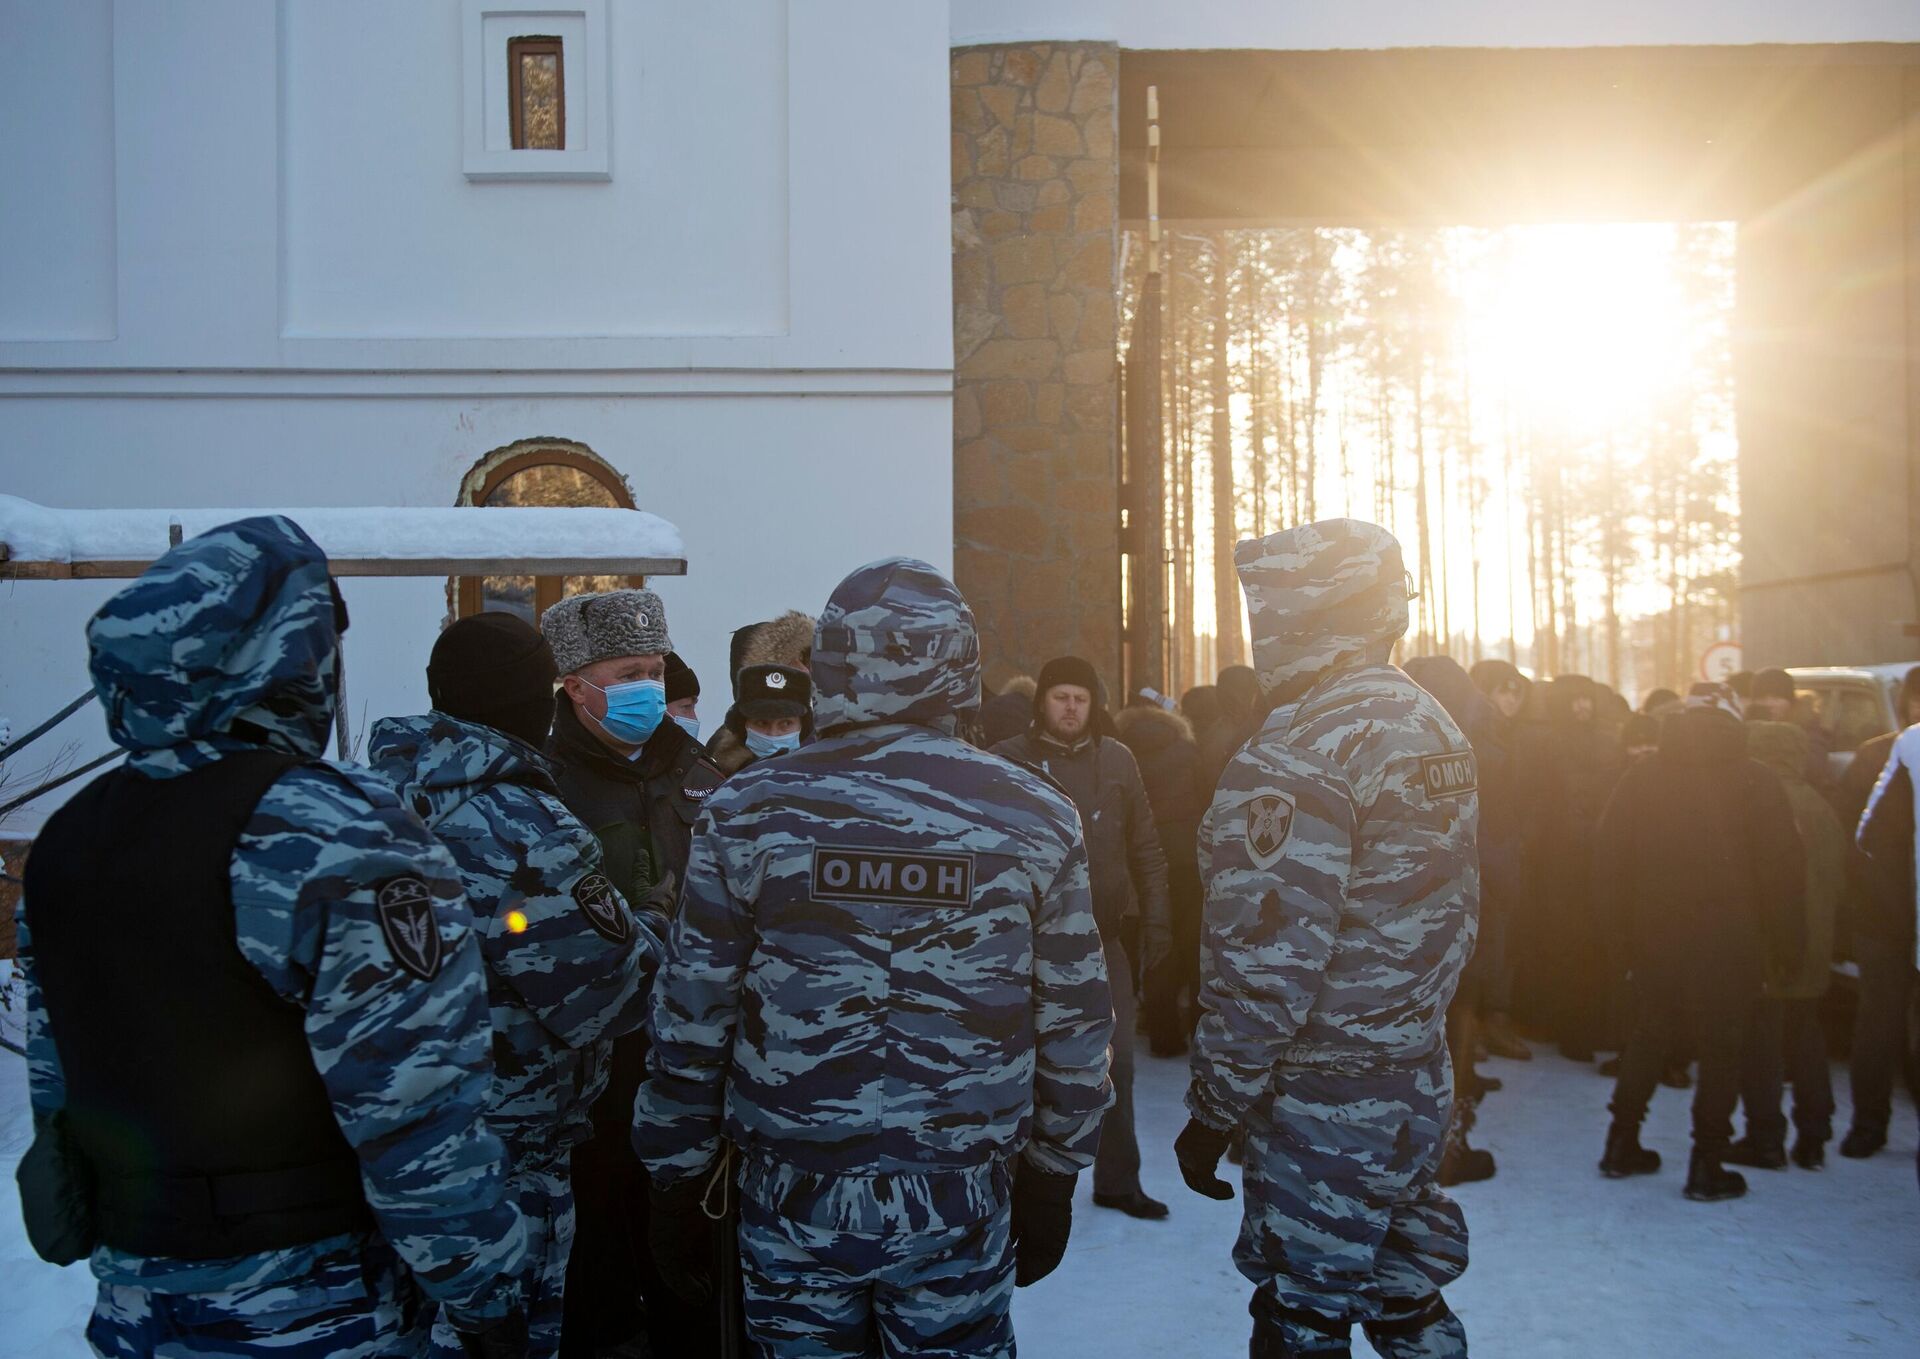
952;42;1119;699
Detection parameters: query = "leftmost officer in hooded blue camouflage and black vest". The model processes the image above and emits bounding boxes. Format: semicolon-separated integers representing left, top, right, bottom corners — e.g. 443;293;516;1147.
21;516;526;1359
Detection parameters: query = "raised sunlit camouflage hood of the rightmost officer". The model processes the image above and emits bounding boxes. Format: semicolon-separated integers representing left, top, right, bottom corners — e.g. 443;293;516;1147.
1233;518;1407;693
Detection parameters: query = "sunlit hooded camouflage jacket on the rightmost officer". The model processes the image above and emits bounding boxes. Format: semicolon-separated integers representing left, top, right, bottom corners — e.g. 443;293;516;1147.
1188;520;1480;1127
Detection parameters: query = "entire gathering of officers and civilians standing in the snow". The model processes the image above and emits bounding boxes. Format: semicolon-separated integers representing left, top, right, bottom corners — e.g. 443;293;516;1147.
7;518;1920;1359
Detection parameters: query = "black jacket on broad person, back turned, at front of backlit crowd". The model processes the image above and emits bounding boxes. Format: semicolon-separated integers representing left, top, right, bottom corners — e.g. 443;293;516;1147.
1594;708;1807;1004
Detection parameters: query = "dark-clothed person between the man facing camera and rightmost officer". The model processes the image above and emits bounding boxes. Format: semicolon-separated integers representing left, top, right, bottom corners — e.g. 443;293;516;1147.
1114;701;1212;1058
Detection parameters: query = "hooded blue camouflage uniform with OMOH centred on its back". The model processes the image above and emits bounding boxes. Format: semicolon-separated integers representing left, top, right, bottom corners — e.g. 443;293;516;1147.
634;559;1112;1357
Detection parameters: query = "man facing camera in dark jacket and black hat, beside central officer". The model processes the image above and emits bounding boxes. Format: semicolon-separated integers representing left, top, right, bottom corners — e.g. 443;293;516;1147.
993;656;1167;1219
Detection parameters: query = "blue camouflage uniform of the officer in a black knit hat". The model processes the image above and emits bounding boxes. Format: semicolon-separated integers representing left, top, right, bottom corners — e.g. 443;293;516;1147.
369;712;666;1357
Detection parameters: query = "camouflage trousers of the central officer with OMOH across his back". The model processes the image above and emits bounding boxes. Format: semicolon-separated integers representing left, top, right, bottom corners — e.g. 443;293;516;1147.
739;1194;1014;1359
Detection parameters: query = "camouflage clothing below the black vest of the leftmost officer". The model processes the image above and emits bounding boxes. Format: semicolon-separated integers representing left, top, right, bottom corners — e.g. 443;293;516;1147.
86;1242;426;1359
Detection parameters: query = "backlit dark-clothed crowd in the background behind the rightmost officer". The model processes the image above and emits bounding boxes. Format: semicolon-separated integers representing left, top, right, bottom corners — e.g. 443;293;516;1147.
1090;656;1920;1200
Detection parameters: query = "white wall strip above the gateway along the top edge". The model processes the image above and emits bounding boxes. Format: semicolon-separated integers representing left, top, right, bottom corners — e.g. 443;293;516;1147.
952;0;1920;52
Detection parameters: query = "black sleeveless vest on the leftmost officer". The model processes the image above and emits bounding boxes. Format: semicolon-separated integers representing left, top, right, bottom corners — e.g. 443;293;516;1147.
23;751;372;1259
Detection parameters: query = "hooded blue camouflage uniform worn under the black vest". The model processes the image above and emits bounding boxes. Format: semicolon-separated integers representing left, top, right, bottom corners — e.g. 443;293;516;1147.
19;516;526;1359
